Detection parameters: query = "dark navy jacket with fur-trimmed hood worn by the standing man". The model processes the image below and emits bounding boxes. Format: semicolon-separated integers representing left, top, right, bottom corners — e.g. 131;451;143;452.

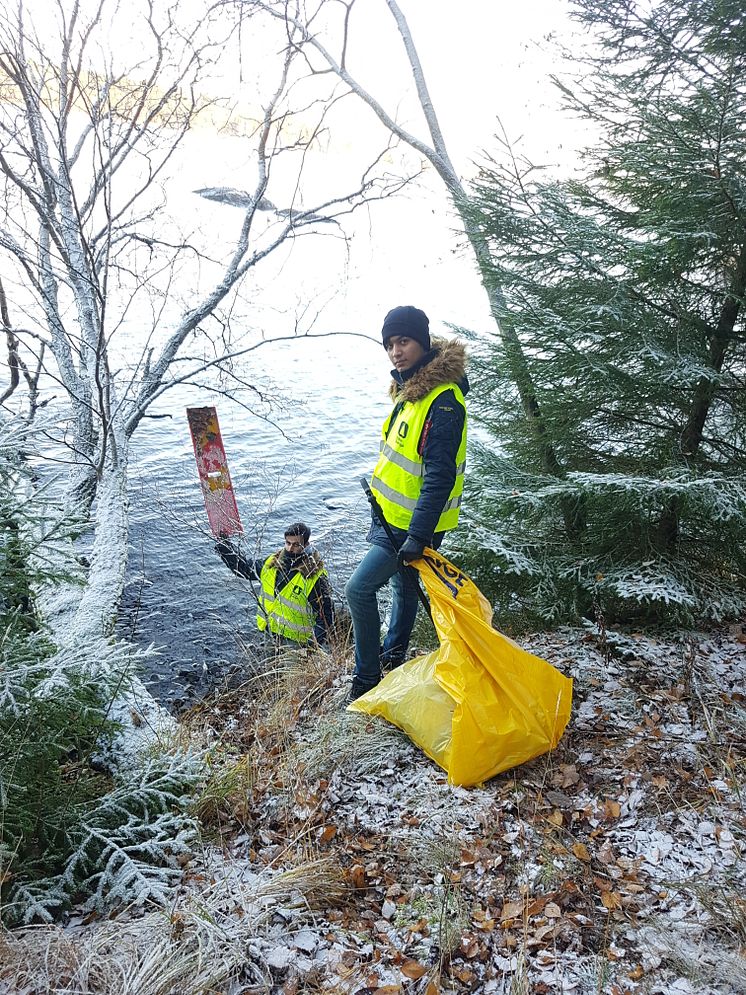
368;338;469;549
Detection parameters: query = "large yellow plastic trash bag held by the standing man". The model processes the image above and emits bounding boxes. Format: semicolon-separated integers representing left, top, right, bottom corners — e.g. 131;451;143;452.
348;549;572;785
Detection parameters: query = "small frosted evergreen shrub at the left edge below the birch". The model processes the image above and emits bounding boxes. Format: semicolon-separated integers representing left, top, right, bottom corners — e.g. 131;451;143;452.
0;424;201;925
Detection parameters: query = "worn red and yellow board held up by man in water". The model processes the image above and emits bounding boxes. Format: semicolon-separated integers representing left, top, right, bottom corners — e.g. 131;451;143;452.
187;408;243;537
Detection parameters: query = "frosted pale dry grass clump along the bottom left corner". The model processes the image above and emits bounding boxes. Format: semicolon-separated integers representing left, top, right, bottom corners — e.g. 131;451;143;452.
0;859;346;995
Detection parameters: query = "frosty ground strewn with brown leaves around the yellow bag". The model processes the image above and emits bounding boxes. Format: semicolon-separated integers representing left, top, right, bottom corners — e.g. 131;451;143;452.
0;627;746;995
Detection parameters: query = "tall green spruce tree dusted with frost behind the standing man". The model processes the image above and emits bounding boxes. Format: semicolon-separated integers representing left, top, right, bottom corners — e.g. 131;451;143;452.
462;0;746;622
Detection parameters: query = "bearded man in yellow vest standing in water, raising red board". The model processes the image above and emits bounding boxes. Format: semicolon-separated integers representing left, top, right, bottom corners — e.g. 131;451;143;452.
215;522;334;646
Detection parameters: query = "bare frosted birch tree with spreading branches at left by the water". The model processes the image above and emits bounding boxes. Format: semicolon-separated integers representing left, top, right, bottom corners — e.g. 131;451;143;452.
0;0;405;638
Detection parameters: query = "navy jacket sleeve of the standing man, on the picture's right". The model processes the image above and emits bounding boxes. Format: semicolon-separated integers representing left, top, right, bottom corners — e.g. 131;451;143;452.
407;390;466;545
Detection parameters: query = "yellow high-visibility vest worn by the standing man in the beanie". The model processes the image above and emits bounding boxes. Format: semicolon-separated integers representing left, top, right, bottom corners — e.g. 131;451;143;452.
370;383;466;532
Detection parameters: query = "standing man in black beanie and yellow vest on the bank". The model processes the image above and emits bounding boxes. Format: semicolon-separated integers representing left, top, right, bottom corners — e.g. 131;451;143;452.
345;305;469;700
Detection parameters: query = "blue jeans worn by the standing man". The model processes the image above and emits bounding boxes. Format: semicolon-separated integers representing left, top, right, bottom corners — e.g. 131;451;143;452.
345;545;418;687
